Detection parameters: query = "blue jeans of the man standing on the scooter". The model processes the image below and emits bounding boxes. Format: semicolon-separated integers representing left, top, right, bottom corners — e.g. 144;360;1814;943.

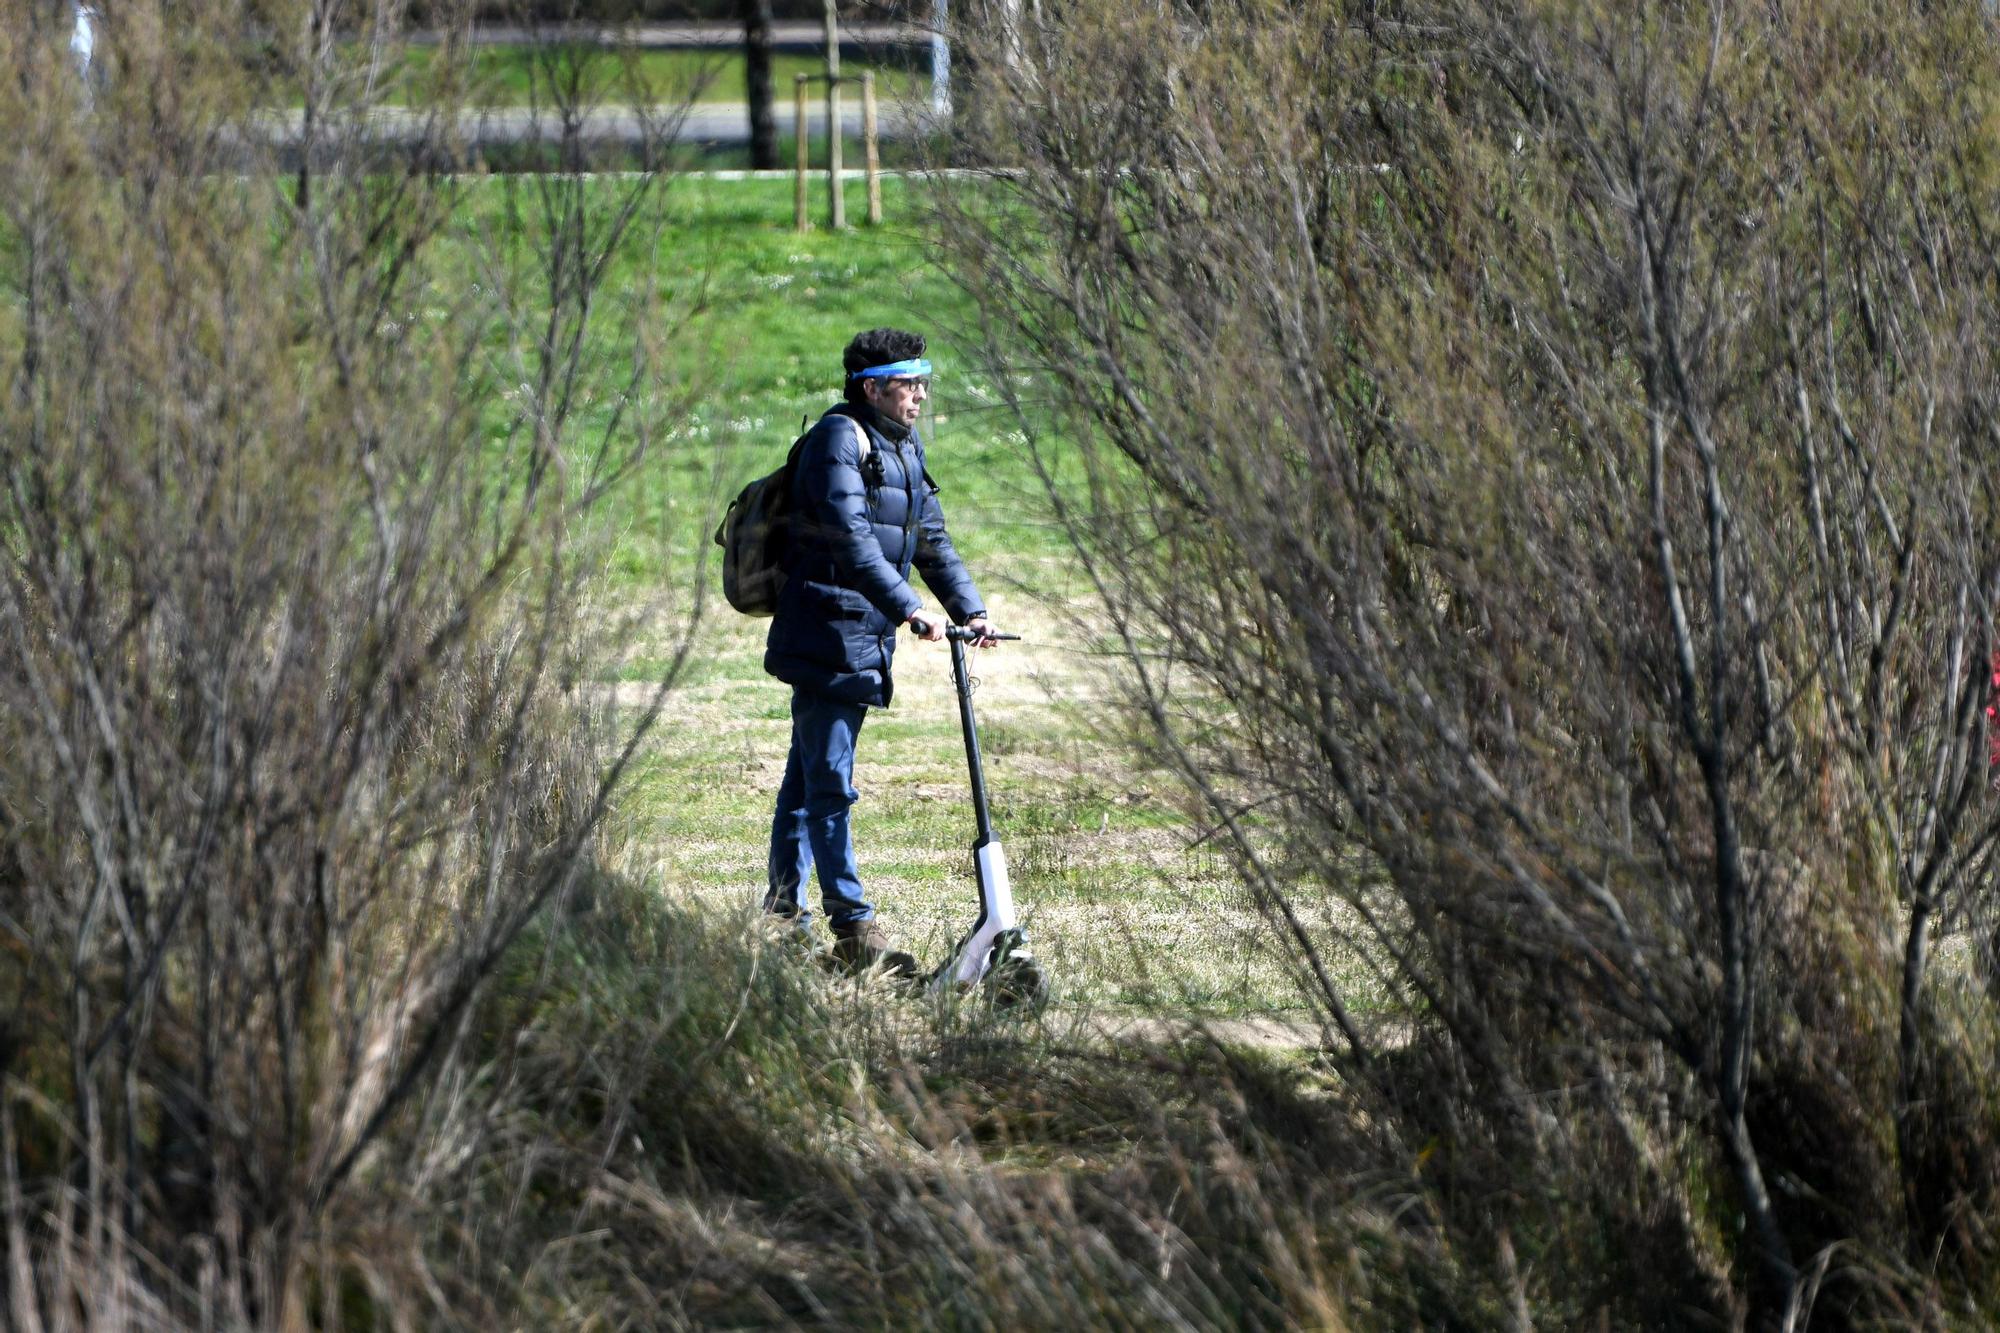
764;689;874;927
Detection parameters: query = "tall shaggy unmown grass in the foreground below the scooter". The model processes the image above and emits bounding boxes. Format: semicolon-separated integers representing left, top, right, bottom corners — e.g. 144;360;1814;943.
398;877;1478;1327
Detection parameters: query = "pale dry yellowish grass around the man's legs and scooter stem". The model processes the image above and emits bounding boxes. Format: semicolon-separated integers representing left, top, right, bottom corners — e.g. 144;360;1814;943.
604;572;1360;1017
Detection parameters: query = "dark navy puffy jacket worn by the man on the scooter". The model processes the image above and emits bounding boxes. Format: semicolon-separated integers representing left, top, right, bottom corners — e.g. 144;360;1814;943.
764;404;984;707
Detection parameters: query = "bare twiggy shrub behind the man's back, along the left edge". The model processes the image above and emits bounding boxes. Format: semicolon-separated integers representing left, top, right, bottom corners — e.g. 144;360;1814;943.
0;2;696;1329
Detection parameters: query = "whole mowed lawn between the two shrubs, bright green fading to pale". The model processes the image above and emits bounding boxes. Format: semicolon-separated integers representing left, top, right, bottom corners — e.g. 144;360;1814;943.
564;180;1336;1015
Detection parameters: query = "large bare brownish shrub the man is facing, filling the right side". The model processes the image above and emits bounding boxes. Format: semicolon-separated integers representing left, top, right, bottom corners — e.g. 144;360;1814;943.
940;0;2000;1323
